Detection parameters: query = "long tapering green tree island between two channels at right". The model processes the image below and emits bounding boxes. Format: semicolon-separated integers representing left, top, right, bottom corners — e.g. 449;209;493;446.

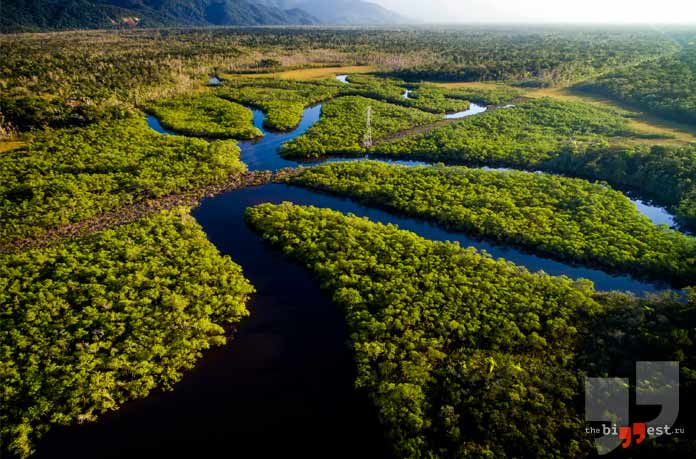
290;162;696;285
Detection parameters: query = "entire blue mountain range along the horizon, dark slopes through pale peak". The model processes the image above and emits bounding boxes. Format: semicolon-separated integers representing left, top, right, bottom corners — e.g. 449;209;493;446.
0;0;404;32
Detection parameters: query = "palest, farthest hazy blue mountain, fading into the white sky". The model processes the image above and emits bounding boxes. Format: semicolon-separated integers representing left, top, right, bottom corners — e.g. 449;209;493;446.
255;0;408;24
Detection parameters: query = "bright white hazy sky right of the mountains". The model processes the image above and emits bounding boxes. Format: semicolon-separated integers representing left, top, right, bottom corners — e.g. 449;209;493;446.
370;0;696;24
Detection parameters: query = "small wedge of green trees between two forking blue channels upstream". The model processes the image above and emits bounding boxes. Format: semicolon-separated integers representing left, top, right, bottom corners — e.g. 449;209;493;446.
218;79;341;131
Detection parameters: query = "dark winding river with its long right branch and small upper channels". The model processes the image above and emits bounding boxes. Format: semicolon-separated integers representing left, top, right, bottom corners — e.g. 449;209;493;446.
42;84;680;459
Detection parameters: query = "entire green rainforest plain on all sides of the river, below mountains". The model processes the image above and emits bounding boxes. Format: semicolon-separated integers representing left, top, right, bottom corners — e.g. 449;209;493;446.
0;26;696;458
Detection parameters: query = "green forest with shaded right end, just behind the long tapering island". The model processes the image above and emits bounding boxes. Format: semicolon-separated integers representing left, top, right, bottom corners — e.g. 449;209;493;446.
371;99;696;229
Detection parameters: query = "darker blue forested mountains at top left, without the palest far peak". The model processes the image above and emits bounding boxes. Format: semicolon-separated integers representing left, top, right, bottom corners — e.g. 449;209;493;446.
0;0;319;32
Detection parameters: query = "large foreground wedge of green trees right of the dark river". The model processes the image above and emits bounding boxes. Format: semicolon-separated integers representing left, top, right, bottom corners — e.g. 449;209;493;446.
247;203;696;458
